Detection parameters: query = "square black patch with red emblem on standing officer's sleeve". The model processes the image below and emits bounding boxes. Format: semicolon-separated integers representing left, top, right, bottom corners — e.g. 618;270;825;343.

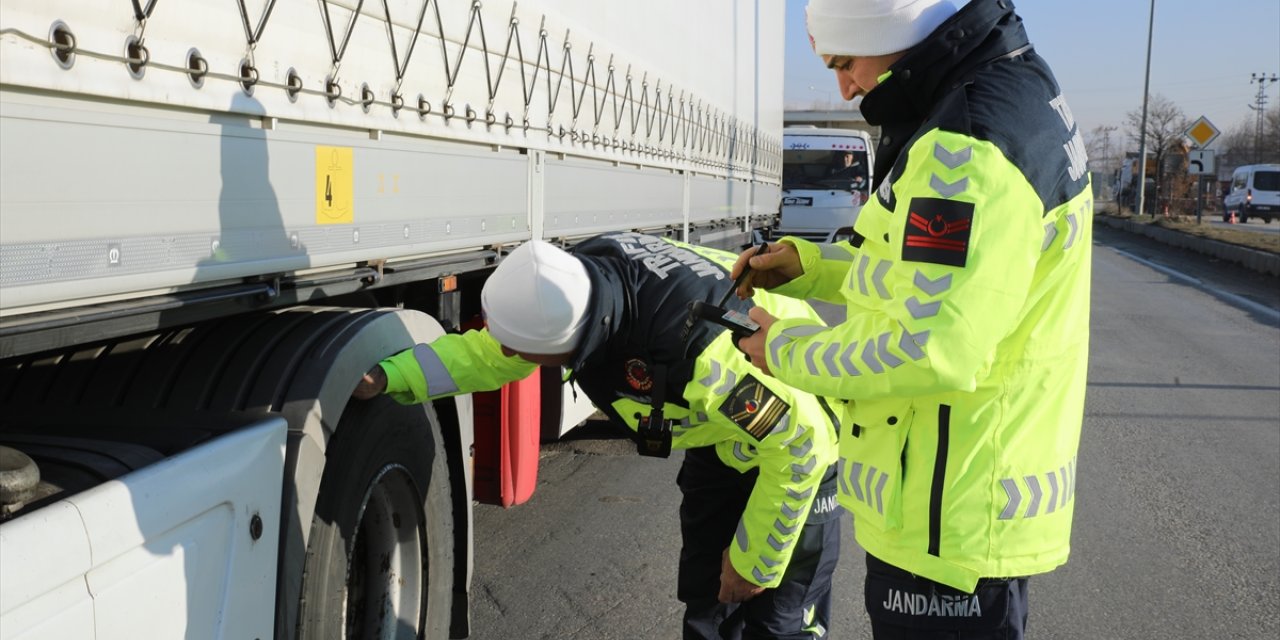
902;197;973;266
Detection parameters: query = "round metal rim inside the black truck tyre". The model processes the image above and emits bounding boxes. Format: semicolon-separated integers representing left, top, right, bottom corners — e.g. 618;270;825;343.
346;465;426;639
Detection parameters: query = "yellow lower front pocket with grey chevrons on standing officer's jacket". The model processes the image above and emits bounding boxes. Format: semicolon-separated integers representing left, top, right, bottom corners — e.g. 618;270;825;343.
837;404;913;531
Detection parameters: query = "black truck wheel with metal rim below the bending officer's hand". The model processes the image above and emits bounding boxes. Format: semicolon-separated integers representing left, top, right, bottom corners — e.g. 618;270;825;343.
298;397;454;640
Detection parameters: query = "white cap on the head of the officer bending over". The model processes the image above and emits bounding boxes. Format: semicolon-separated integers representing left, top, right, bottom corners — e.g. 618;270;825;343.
480;241;591;355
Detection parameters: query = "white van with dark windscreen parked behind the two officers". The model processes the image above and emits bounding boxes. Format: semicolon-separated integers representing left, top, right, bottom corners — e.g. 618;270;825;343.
774;127;876;242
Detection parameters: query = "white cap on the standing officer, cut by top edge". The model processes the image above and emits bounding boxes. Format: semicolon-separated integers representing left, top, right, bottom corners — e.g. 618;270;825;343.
805;0;956;55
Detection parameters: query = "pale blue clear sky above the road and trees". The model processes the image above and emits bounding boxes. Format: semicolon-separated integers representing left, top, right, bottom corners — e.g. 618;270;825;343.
783;0;1280;146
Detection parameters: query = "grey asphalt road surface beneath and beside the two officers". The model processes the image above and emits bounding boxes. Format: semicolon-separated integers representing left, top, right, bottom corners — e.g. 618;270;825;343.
472;228;1280;640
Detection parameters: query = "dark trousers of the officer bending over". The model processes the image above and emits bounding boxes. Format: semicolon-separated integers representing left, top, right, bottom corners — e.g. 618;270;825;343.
676;447;842;640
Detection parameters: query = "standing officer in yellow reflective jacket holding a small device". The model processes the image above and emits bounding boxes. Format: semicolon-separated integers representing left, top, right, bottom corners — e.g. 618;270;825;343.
740;0;1093;639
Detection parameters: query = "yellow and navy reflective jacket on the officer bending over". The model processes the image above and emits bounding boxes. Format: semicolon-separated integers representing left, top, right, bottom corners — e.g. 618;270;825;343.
381;233;836;588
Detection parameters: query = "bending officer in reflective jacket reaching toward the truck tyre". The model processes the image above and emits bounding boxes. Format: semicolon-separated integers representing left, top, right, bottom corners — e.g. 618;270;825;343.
355;233;840;639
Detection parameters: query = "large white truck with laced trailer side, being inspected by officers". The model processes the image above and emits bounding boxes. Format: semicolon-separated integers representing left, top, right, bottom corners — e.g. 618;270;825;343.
0;0;783;640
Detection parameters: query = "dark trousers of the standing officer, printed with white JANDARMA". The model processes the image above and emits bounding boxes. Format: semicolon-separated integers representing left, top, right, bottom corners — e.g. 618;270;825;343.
865;553;1027;640
